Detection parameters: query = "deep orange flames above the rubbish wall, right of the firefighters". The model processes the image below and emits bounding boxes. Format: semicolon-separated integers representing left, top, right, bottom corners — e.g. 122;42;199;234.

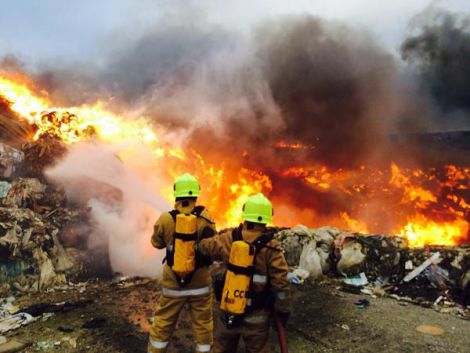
282;162;470;246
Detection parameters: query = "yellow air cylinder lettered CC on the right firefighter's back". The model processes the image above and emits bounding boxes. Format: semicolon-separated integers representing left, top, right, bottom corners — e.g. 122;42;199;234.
220;240;254;315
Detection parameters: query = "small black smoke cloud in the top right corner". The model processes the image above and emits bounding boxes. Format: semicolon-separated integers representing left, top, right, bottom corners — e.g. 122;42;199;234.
401;9;470;114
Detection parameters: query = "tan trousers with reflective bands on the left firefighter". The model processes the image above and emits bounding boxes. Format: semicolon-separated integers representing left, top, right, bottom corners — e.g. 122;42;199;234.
148;291;213;353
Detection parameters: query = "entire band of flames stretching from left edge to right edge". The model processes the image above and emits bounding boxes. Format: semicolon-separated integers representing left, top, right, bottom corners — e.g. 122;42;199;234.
0;73;470;246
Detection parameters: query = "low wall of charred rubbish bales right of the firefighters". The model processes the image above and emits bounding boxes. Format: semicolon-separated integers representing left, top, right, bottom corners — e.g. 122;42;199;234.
276;226;470;306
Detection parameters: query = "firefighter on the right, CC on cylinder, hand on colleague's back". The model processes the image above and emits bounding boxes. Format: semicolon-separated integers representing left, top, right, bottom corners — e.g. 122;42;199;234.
199;193;291;353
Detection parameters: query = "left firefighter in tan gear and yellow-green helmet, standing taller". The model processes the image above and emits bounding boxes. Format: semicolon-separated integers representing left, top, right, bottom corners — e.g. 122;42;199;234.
148;173;215;353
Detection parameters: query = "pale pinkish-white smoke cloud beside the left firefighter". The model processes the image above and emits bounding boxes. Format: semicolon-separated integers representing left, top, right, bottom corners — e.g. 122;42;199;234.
46;143;170;276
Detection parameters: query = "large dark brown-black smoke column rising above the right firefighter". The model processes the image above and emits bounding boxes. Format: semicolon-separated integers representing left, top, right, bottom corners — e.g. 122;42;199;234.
258;16;397;167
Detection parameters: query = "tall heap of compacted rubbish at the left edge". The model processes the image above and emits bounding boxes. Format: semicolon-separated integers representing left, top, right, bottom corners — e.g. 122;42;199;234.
0;135;87;294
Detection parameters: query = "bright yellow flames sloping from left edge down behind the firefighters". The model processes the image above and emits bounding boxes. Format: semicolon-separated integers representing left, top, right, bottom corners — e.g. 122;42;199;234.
0;76;271;227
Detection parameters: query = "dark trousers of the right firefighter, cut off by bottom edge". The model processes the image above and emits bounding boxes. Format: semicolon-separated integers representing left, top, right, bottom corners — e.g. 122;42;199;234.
214;314;270;353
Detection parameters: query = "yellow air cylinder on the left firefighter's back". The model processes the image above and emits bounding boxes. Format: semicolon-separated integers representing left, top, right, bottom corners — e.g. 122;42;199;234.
172;213;197;277
